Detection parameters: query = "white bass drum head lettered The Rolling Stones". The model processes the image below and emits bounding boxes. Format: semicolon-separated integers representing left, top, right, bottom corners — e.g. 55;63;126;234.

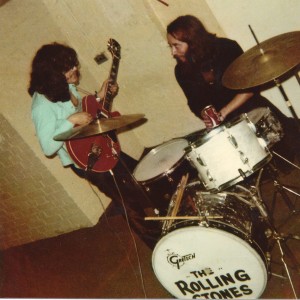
152;226;267;299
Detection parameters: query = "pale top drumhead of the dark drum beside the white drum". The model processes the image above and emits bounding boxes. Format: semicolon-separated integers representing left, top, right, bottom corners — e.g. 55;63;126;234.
133;139;188;181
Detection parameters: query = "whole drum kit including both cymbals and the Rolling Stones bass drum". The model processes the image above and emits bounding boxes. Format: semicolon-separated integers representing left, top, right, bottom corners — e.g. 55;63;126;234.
55;28;300;299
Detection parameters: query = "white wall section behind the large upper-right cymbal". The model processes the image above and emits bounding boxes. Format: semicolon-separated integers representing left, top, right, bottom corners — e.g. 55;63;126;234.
207;0;300;117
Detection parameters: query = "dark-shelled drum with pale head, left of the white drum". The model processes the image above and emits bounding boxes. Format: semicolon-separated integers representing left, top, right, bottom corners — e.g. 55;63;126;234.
133;138;194;212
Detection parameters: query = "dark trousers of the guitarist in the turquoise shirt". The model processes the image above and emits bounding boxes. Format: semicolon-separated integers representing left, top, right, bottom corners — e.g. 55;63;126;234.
71;152;161;249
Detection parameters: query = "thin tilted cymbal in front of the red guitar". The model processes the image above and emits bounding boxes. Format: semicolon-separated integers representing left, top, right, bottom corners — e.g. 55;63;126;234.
53;114;145;141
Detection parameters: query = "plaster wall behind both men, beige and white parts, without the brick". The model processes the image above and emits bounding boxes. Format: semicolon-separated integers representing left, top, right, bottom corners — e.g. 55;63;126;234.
0;0;299;245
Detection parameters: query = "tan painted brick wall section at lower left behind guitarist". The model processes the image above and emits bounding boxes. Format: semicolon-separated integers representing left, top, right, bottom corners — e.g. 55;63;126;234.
0;114;93;249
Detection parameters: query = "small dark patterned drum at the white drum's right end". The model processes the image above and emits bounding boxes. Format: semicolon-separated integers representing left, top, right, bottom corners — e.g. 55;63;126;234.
247;107;284;148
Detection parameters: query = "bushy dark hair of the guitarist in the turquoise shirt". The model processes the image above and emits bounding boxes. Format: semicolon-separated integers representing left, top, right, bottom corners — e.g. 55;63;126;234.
28;42;79;102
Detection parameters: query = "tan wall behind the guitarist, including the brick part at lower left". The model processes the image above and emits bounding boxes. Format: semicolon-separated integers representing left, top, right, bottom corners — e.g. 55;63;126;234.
0;0;218;248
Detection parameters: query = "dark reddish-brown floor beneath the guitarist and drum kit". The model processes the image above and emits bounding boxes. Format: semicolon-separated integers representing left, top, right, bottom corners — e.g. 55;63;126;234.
0;155;300;299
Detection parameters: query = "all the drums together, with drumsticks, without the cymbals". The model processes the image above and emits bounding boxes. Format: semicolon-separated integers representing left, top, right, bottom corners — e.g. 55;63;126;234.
133;108;281;298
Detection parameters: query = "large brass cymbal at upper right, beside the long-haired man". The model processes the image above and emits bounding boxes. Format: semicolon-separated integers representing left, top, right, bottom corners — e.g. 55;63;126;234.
222;31;300;90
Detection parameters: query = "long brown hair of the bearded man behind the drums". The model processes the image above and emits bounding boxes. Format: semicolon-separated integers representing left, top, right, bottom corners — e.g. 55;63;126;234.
167;15;216;67
